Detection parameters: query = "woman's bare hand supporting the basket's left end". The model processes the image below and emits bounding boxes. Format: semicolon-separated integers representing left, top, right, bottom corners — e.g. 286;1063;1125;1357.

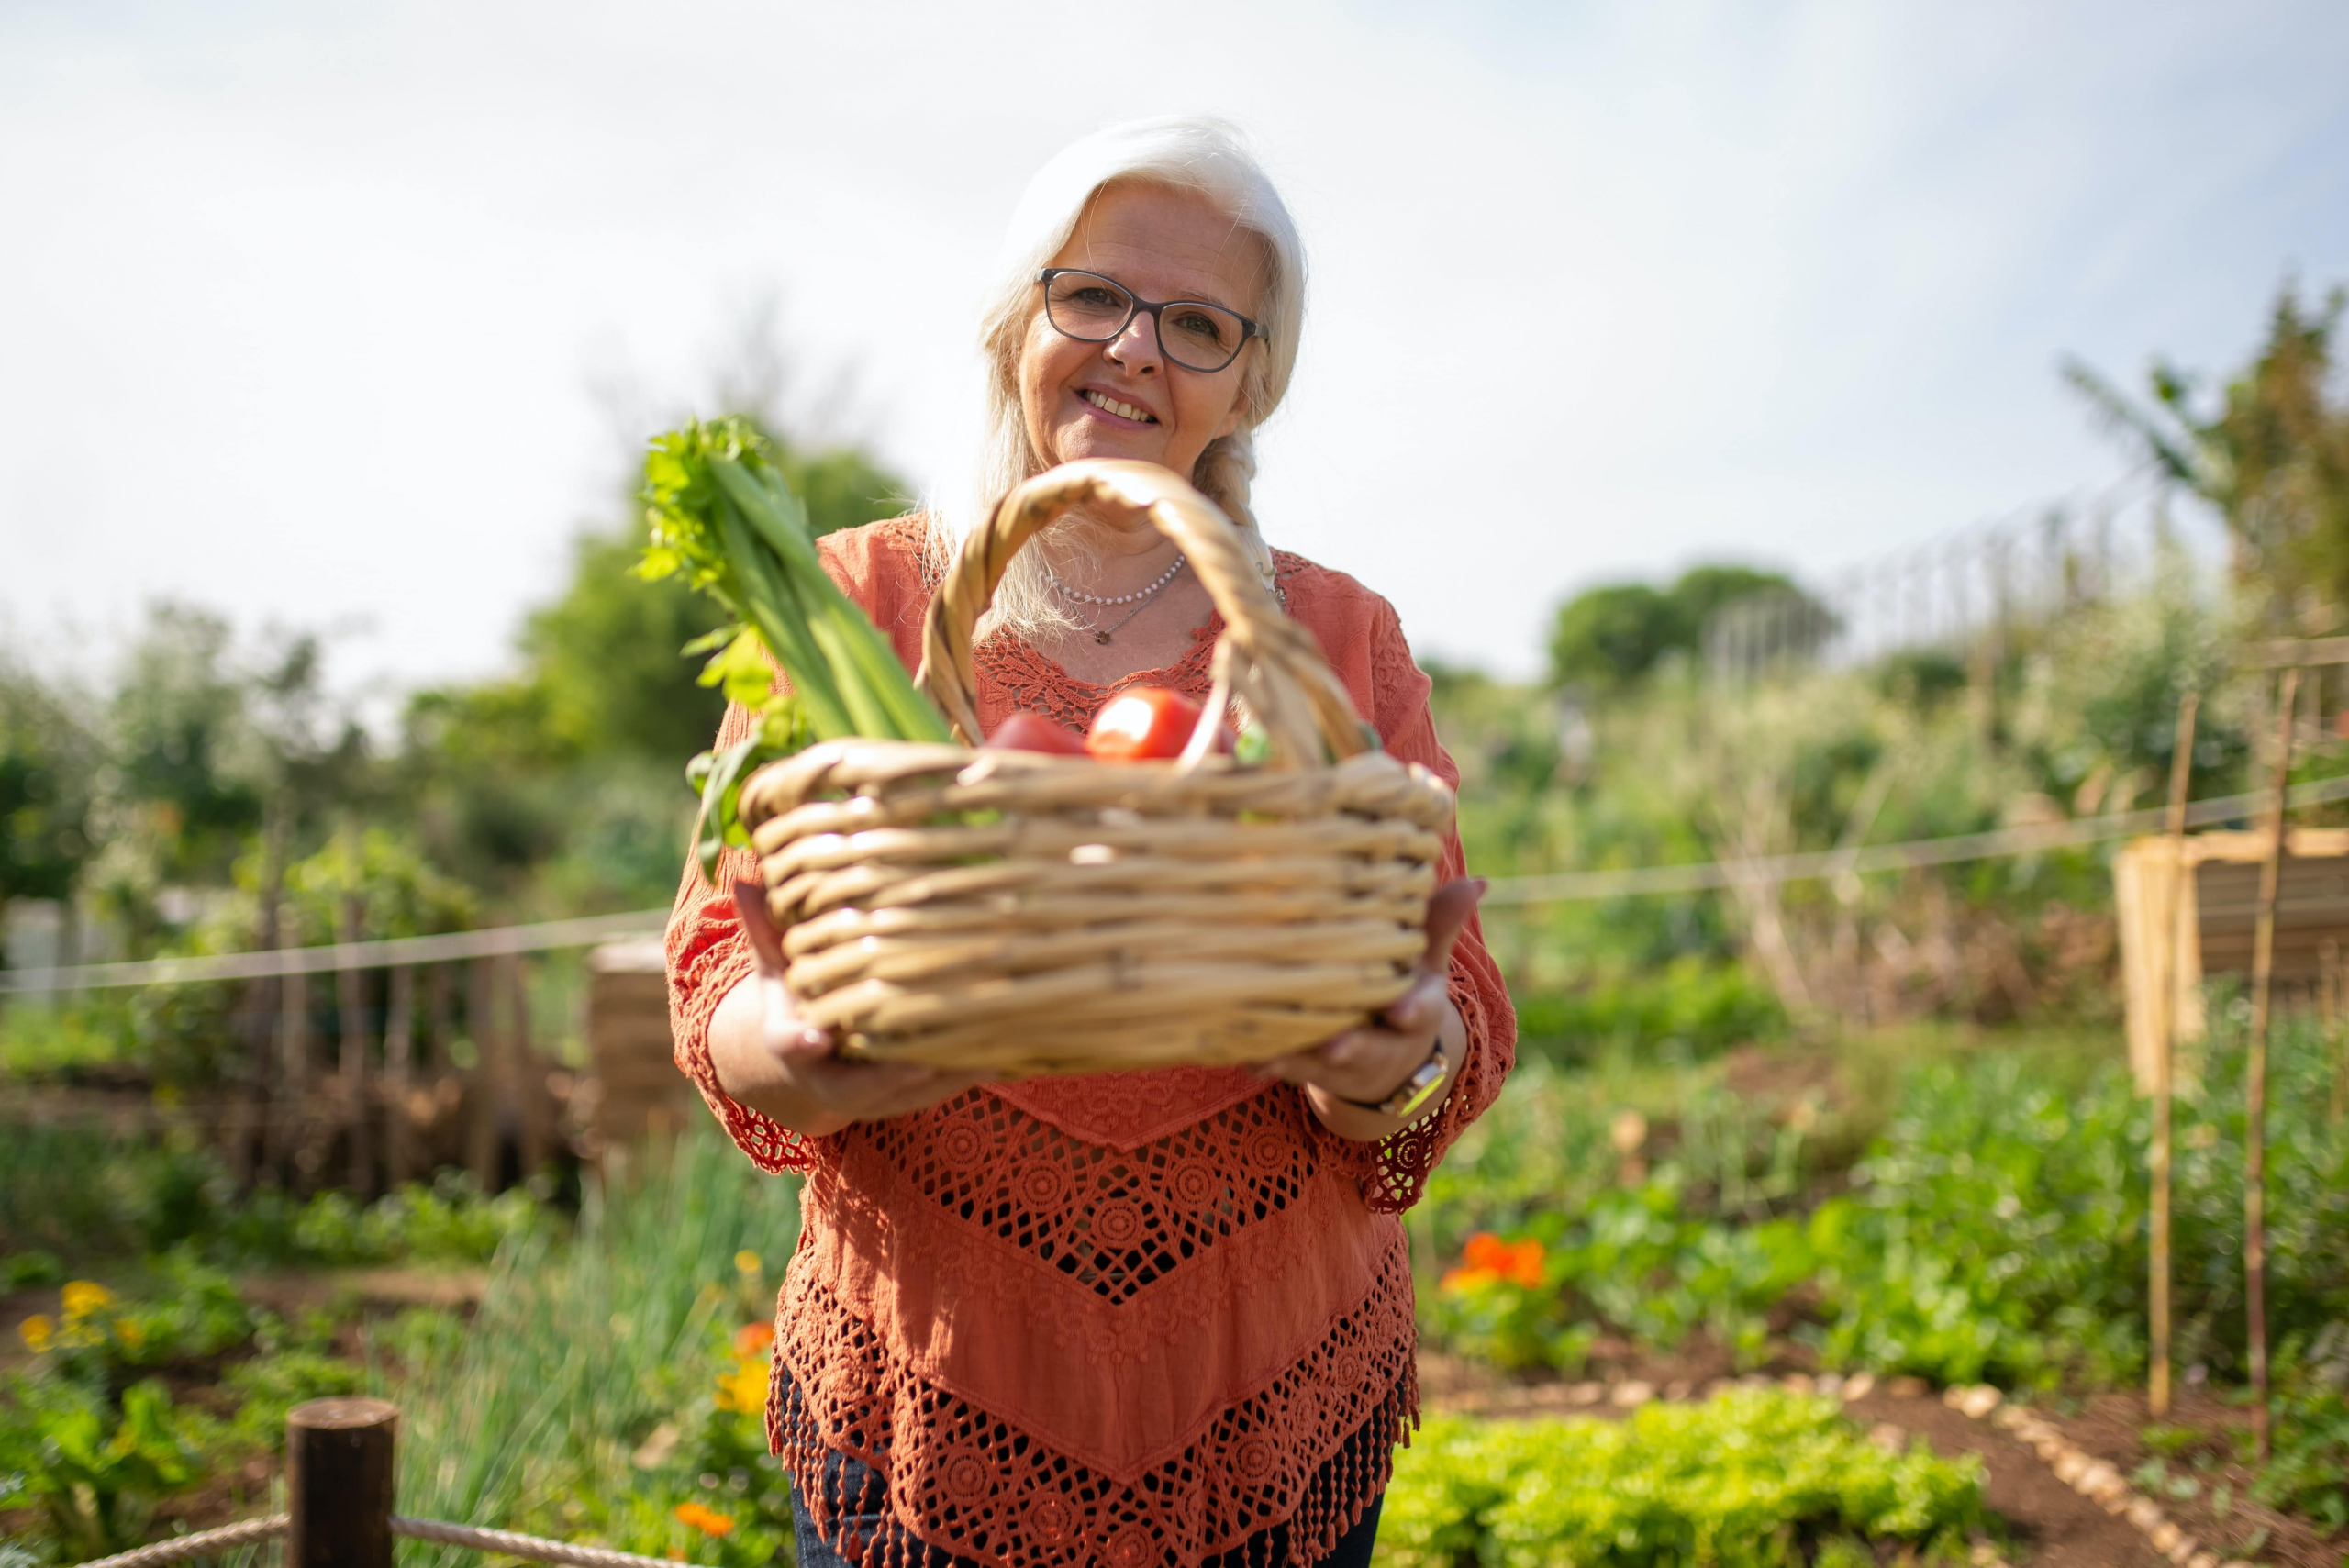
709;883;994;1139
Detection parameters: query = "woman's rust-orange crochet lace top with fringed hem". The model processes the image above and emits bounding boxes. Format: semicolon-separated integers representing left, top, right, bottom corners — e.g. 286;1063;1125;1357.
667;518;1515;1568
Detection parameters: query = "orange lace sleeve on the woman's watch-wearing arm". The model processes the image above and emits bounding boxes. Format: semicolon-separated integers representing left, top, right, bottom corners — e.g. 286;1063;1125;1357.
1325;601;1518;1214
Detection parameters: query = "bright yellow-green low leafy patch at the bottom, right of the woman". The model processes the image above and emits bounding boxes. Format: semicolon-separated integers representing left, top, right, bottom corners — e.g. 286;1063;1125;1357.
1375;1390;1985;1568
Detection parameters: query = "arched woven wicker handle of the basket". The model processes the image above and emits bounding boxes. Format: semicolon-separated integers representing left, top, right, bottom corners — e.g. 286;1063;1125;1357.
914;458;1367;768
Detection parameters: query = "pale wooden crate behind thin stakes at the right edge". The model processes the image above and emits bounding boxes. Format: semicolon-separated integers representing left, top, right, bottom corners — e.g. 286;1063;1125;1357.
2111;828;2349;1094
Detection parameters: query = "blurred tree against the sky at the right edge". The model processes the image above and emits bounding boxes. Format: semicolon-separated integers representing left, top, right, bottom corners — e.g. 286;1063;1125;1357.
2065;284;2349;631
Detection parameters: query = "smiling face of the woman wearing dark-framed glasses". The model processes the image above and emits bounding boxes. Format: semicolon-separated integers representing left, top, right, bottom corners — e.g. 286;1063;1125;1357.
1019;185;1264;479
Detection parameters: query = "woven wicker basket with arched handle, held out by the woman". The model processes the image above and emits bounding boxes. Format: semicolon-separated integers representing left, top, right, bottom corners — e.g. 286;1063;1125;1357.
742;460;1452;1075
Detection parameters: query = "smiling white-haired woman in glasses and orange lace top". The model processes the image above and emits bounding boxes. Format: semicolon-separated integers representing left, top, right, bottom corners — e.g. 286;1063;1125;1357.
670;119;1515;1568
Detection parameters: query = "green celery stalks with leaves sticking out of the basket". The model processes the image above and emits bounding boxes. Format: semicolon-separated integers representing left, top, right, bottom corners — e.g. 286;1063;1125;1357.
637;416;953;878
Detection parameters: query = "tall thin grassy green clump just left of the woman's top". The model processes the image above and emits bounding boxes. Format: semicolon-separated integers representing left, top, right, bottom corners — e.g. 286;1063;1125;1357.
373;1129;798;1568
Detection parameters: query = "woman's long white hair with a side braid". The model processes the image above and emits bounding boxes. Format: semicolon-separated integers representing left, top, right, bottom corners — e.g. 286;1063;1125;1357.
928;115;1306;639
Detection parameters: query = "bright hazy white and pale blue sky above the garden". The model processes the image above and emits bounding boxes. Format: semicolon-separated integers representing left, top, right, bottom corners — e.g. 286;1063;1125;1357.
0;0;2349;683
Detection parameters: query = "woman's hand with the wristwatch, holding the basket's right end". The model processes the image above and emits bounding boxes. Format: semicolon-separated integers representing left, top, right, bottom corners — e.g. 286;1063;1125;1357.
1257;878;1485;1139
